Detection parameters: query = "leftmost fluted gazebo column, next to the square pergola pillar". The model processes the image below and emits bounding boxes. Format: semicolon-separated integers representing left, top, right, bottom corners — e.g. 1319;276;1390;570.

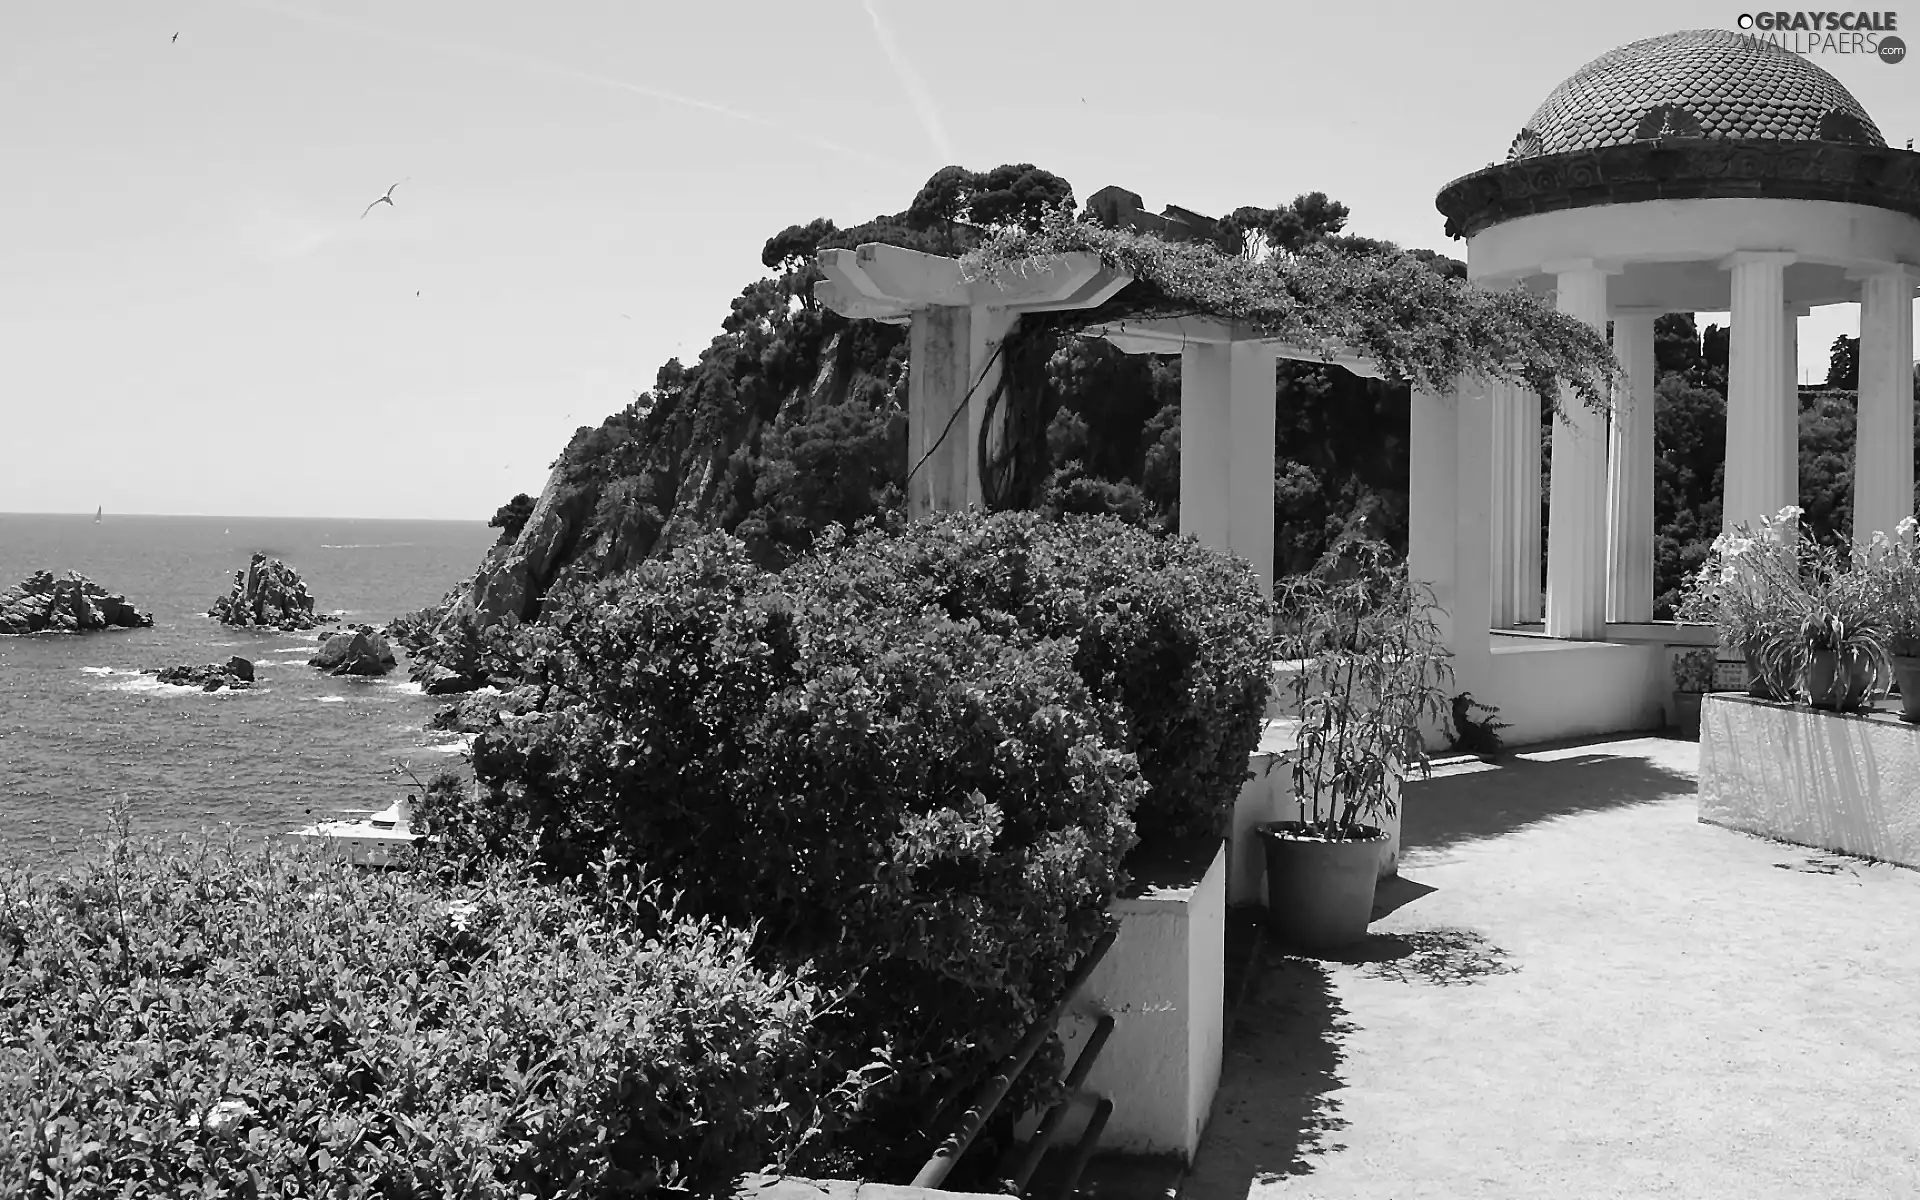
1488;382;1542;630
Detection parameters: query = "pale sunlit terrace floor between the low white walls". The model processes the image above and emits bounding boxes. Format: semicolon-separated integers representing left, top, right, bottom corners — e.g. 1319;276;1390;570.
1183;737;1920;1200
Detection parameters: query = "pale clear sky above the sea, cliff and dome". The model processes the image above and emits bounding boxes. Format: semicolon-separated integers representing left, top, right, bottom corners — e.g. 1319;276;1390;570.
0;0;1920;520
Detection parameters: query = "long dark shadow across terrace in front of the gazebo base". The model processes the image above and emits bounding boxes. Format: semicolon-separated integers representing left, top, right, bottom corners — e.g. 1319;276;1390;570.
1400;751;1693;852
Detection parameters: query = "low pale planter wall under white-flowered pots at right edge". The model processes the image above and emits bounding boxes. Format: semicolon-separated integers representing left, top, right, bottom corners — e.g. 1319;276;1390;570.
1699;693;1920;868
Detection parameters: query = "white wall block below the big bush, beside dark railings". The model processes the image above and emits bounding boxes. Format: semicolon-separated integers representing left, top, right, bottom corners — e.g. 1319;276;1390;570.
1018;833;1227;1162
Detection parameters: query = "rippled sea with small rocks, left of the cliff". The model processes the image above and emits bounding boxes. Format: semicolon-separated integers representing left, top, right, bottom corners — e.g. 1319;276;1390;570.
0;513;495;870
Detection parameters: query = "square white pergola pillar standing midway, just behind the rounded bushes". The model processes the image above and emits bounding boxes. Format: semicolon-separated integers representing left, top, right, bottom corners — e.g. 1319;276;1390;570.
1181;342;1279;595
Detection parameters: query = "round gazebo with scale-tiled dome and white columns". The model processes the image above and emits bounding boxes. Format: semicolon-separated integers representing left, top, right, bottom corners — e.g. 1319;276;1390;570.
1438;29;1920;639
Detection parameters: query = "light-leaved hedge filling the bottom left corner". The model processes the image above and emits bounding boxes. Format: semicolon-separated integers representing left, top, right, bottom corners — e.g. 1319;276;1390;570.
0;829;820;1200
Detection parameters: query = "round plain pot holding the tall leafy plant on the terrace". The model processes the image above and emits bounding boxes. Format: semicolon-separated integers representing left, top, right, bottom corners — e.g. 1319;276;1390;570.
1256;822;1386;950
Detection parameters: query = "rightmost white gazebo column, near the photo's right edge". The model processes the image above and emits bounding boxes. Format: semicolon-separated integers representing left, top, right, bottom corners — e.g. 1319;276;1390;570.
1853;265;1914;541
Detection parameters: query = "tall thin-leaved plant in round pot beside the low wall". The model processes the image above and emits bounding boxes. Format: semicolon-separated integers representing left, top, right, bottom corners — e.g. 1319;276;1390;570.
1260;540;1453;948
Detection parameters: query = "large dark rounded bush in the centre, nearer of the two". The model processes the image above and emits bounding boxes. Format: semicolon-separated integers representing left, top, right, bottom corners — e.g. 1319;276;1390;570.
422;534;1136;1177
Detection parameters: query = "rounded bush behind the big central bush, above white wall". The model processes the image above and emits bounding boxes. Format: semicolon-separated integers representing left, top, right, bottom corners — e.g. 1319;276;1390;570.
787;513;1271;843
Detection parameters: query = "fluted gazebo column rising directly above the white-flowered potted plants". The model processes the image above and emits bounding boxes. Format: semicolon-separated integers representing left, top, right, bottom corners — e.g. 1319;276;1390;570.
1720;250;1799;530
